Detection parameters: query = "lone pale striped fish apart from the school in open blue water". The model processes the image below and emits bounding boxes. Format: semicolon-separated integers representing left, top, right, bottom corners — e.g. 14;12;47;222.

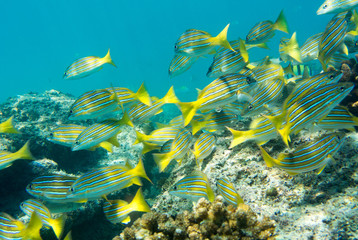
63;49;117;80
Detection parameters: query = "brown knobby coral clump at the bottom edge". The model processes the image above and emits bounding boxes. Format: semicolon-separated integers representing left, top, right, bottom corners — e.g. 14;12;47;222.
119;197;275;240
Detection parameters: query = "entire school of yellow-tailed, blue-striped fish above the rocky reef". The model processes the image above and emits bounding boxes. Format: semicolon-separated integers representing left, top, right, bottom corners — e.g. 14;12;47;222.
0;0;358;239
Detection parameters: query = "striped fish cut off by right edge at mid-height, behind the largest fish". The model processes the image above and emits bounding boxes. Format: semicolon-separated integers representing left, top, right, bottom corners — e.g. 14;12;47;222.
316;106;358;131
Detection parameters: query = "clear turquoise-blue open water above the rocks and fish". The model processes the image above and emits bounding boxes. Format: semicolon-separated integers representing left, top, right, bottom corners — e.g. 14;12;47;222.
0;0;331;102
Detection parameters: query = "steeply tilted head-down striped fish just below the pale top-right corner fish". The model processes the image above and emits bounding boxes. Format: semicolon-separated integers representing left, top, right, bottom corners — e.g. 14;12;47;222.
318;18;348;71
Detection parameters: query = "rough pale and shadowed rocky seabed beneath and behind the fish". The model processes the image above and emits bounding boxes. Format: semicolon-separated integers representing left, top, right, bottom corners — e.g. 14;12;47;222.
0;90;358;239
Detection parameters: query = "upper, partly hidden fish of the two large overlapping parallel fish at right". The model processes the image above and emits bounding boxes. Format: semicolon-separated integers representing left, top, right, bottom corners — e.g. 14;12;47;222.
265;71;343;129
